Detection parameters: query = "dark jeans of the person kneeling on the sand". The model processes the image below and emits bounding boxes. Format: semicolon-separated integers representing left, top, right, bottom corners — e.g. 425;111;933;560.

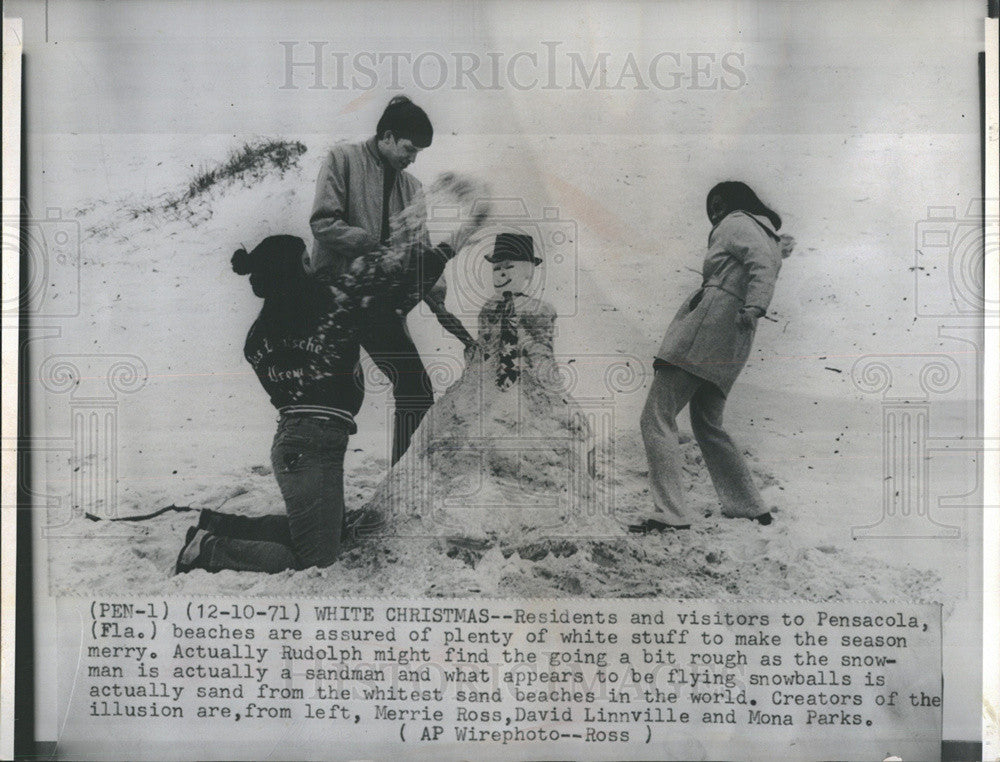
202;416;350;573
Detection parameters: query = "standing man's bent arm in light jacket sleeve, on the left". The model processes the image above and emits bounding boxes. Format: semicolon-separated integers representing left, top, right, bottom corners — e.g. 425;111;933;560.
309;148;377;271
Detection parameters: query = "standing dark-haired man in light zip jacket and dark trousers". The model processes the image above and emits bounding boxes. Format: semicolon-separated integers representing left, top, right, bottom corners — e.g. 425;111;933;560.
306;95;475;463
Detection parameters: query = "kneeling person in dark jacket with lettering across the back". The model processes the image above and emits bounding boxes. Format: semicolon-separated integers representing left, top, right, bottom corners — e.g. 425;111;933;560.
175;235;455;573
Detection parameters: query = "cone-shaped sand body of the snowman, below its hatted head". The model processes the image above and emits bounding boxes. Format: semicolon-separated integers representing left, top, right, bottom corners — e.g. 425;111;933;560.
368;284;622;549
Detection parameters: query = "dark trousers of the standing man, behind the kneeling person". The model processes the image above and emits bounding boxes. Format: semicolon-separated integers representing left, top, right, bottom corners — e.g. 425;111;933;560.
361;312;434;463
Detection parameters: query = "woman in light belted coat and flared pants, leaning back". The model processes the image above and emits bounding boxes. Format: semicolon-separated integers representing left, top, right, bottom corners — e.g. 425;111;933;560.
629;182;787;532
